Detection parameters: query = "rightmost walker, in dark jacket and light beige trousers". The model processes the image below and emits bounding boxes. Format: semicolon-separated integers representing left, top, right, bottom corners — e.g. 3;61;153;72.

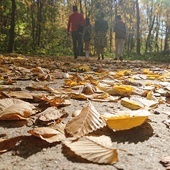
114;15;126;61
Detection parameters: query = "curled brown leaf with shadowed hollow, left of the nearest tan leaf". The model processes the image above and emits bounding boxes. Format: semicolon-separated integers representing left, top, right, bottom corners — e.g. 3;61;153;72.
28;127;65;143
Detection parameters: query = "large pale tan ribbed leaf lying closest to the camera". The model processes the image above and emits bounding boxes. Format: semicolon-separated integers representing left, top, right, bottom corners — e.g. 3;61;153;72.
64;135;118;164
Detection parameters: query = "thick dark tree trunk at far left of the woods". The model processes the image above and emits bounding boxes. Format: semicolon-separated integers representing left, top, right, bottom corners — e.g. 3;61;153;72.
8;0;16;53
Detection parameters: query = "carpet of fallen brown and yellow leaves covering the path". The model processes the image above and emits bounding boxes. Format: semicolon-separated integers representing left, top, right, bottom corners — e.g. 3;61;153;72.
0;55;170;164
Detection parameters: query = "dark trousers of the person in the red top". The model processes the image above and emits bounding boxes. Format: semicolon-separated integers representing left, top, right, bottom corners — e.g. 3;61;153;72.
72;31;83;58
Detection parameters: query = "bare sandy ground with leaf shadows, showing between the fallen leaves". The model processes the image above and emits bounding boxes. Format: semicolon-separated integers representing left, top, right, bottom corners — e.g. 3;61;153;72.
0;55;170;170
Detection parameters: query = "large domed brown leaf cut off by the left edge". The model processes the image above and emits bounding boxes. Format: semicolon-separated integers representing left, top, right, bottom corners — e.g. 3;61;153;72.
0;98;35;120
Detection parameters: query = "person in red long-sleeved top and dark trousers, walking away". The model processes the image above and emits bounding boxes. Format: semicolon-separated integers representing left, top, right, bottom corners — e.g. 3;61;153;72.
67;6;85;59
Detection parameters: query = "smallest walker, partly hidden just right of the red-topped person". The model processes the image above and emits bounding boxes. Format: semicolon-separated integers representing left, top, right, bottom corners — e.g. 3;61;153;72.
83;18;92;59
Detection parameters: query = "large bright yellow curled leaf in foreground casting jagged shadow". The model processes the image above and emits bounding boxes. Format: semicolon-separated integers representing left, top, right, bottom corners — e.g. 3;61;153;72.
101;110;151;131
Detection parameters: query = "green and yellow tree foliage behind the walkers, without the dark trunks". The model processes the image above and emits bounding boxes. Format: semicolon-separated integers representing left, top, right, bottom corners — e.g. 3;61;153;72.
0;0;169;61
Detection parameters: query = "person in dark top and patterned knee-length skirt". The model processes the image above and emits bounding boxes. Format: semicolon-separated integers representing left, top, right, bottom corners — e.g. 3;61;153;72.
94;12;108;60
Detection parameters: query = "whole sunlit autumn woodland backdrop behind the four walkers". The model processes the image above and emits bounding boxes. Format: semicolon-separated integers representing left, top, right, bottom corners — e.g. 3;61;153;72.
0;0;170;61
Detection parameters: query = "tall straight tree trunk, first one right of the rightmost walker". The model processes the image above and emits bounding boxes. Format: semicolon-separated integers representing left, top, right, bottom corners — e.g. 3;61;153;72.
136;0;140;54
